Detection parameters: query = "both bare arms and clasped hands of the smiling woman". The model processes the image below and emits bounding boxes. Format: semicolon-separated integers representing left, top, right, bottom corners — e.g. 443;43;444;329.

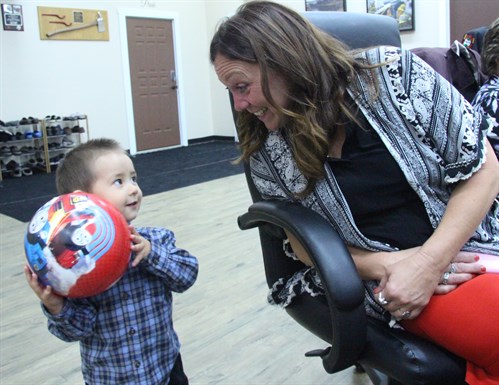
287;142;499;318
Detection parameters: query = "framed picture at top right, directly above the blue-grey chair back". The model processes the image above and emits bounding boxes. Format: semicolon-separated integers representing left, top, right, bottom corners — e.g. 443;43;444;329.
366;0;415;31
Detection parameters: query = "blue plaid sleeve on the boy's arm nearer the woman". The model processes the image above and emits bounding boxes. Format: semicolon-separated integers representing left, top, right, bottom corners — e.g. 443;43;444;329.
137;228;198;293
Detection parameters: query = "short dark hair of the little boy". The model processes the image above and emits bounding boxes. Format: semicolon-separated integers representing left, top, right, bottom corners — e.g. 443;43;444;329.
55;138;128;195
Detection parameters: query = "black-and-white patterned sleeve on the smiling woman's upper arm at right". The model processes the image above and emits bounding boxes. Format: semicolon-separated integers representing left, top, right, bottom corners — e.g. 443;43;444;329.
400;51;491;183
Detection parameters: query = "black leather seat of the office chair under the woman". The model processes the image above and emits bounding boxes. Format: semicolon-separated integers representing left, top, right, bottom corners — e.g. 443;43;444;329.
286;294;466;385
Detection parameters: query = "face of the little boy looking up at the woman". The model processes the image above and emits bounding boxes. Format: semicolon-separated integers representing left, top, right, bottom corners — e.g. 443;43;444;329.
90;151;142;222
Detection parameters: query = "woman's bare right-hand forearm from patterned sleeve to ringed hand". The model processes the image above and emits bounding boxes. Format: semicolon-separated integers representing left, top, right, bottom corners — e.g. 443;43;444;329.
379;141;499;318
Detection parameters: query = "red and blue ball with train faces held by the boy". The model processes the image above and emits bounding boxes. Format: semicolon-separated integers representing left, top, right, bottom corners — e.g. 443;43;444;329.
24;192;131;298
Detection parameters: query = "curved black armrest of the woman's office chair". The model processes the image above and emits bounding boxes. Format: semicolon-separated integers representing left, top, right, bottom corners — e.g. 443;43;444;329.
238;201;367;373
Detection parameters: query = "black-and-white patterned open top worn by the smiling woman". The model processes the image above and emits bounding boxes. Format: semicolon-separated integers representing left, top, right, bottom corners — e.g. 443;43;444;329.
250;47;499;318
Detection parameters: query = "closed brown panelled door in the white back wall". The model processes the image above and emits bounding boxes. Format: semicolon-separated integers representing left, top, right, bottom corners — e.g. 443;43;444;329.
126;17;180;151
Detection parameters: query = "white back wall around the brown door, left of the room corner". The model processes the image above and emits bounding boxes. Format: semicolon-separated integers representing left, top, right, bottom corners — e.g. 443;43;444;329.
0;0;215;152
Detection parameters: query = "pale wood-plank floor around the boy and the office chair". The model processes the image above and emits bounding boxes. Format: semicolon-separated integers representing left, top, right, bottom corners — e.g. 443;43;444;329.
0;175;371;385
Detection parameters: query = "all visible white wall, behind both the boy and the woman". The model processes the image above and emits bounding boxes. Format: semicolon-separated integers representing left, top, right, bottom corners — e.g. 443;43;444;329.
0;0;449;153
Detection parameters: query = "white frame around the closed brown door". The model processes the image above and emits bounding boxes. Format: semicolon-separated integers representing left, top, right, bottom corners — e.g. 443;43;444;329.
118;9;188;155
